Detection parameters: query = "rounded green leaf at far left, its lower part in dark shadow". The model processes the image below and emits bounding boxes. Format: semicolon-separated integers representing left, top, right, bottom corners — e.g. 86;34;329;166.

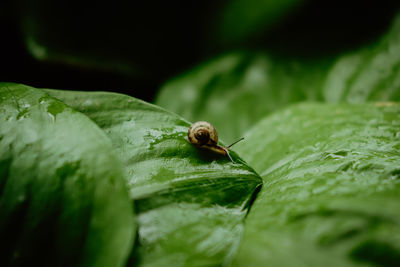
0;83;135;266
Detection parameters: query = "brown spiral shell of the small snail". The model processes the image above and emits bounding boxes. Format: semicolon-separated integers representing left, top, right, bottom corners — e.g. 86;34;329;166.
188;121;218;146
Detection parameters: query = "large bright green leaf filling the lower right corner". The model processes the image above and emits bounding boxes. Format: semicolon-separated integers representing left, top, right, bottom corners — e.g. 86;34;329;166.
233;103;400;266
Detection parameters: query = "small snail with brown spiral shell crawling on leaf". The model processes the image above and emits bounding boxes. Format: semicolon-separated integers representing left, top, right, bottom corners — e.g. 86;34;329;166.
188;121;244;163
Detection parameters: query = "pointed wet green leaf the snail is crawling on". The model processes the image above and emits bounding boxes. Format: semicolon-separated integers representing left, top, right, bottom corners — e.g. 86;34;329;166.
48;90;261;266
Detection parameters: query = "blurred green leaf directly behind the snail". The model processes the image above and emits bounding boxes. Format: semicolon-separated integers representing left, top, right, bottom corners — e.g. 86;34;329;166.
156;53;330;142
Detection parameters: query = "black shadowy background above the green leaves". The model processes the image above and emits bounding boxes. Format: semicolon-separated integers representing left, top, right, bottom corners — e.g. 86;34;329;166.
0;0;400;101
